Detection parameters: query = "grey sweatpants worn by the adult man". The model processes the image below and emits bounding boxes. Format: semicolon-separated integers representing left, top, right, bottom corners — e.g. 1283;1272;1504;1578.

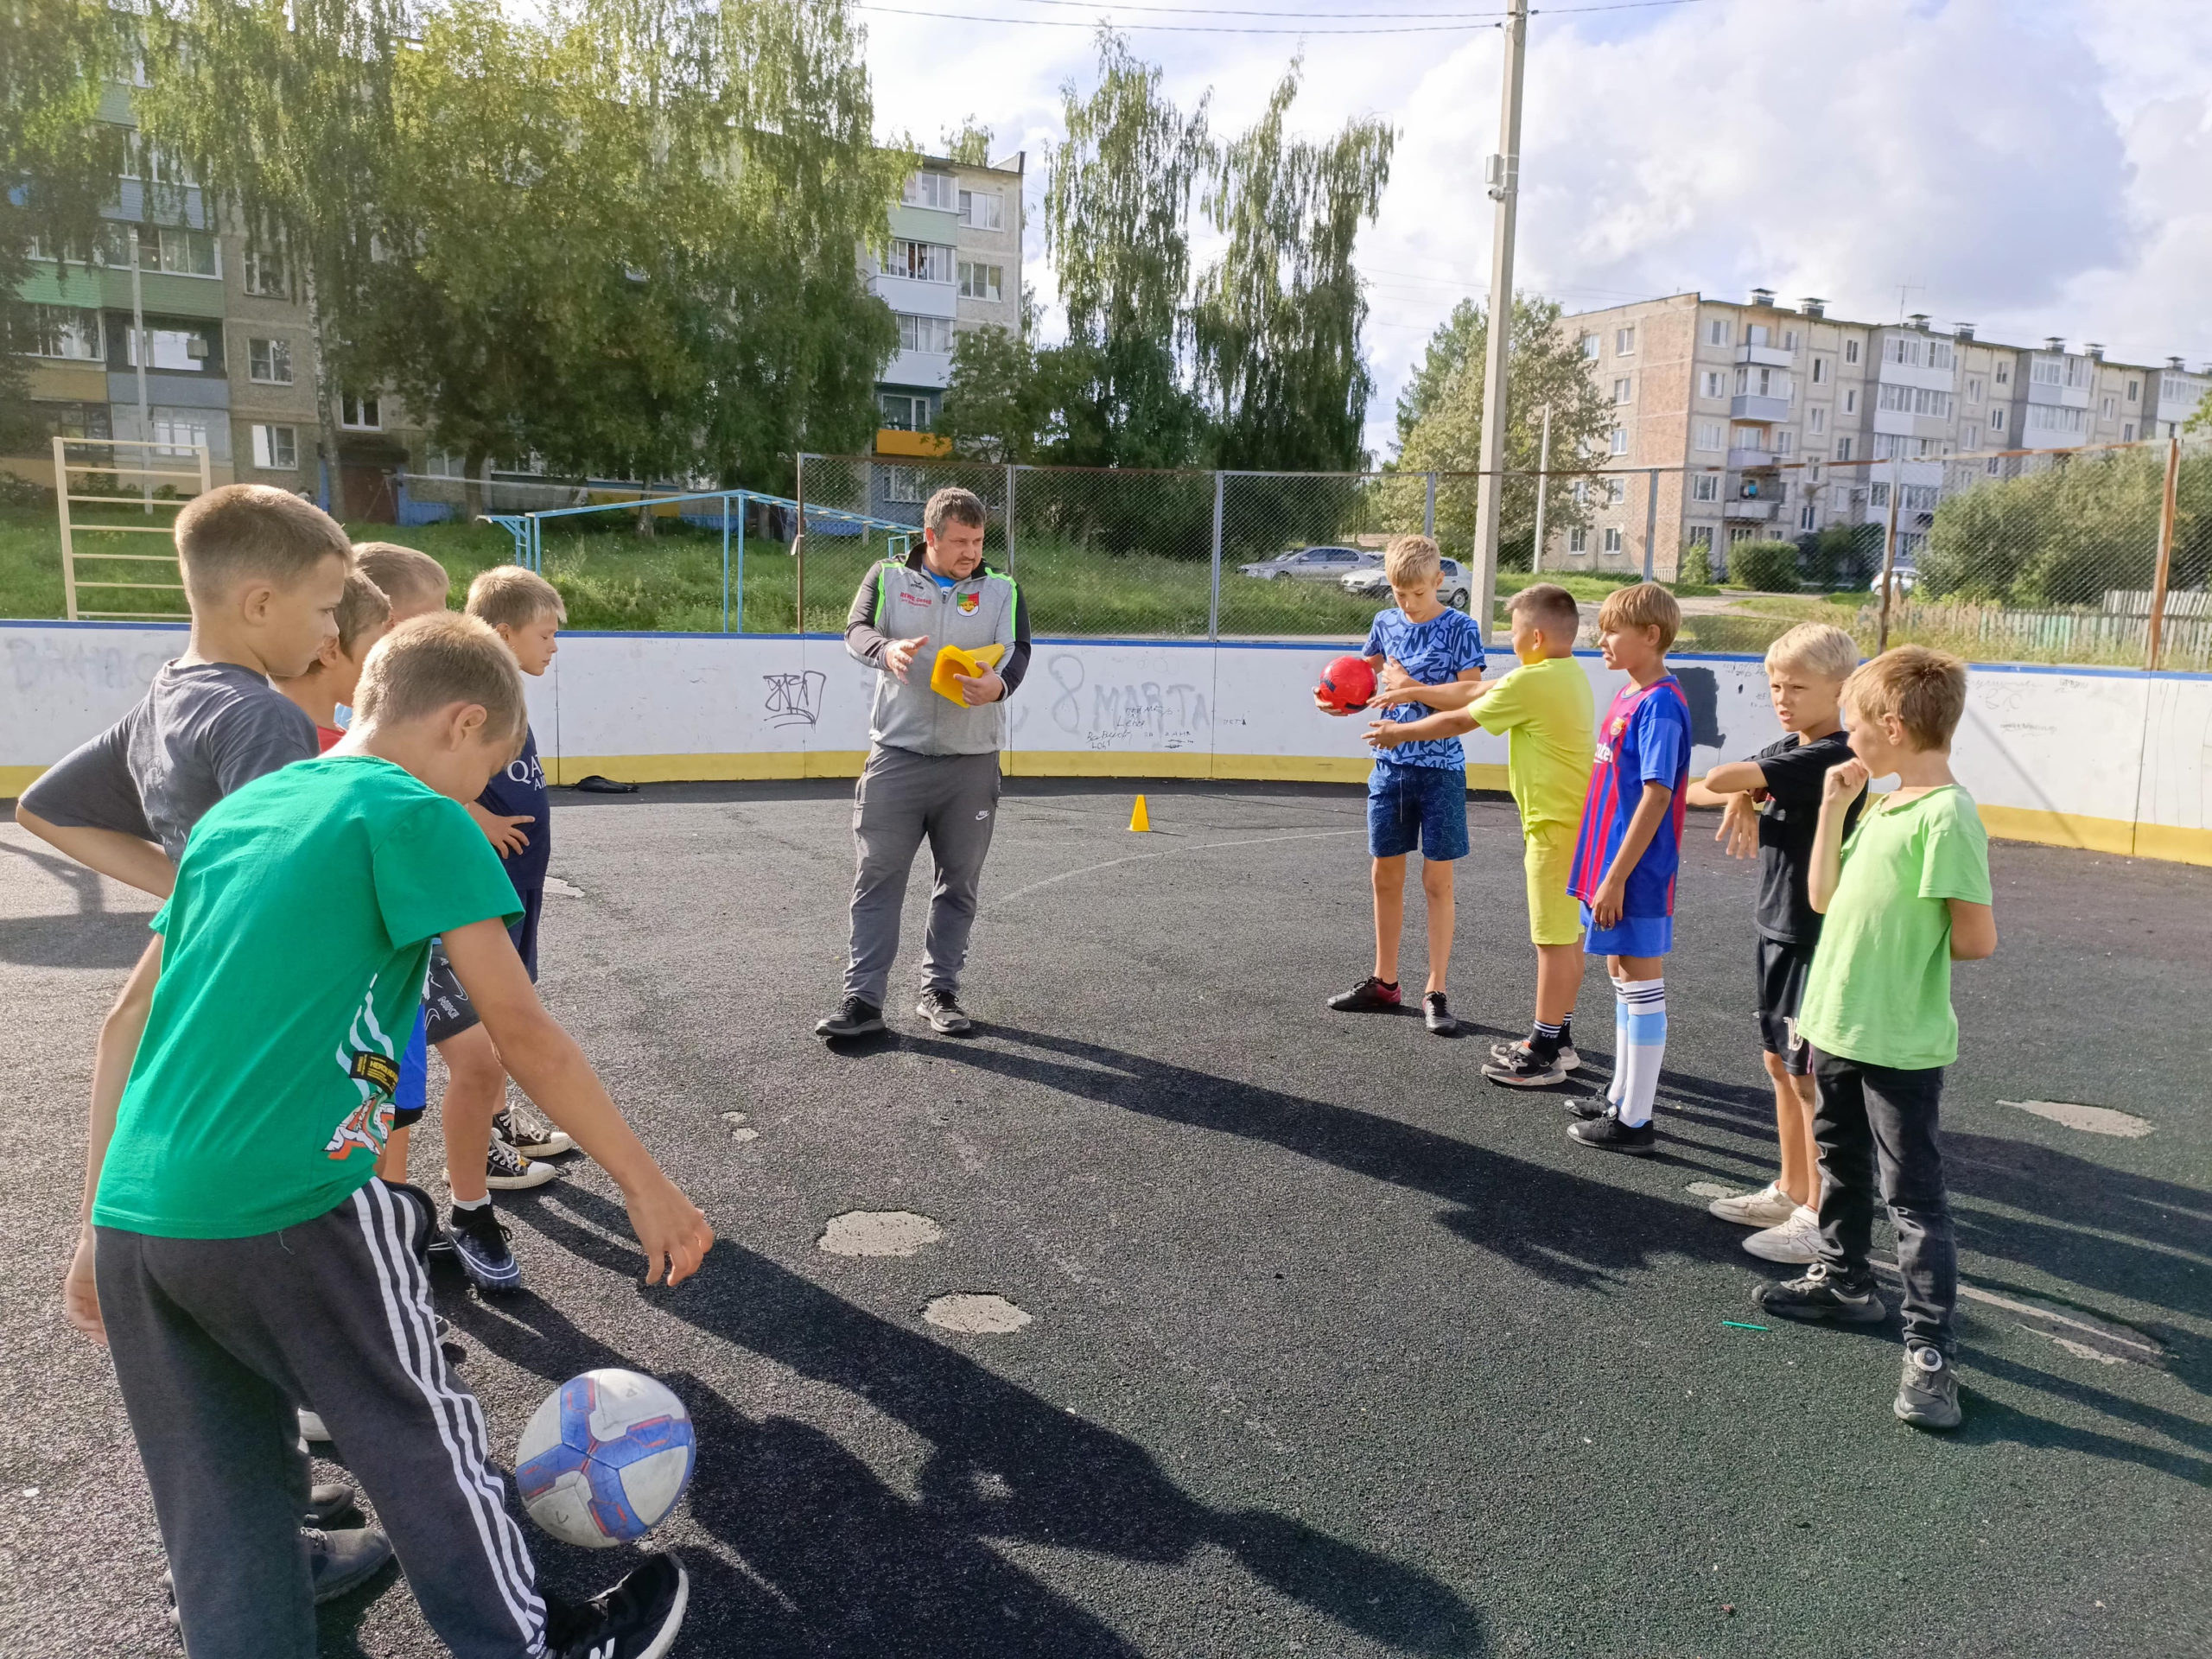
845;743;1000;1008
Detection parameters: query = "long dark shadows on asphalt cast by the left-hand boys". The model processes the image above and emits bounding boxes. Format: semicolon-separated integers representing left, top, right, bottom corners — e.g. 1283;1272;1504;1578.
464;1181;1486;1659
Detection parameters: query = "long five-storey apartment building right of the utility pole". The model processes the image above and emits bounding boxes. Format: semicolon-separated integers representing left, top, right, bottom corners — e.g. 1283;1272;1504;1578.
1544;288;2212;577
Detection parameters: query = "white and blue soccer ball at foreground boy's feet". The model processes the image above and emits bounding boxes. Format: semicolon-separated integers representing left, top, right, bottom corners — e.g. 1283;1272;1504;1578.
515;1370;696;1548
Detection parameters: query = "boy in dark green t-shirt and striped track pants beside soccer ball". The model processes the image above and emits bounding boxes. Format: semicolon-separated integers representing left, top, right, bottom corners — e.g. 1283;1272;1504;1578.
62;617;715;1659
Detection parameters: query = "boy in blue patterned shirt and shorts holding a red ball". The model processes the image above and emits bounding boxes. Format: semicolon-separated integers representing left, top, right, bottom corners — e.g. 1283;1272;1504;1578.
1314;536;1482;1035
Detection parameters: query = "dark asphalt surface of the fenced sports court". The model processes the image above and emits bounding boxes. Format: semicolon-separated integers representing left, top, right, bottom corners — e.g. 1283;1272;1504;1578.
0;783;2212;1659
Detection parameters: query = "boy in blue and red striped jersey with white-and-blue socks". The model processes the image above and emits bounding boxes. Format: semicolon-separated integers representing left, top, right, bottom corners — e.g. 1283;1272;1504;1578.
1566;582;1690;1153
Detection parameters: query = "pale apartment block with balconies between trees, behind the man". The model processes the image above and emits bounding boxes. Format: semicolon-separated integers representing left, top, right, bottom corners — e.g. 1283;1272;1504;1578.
862;153;1027;455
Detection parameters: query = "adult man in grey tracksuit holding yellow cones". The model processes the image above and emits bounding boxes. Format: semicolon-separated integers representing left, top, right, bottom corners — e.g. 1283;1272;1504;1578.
814;489;1028;1038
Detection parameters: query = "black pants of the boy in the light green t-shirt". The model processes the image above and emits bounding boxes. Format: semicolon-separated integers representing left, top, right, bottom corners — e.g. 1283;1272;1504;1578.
1812;1051;1958;1356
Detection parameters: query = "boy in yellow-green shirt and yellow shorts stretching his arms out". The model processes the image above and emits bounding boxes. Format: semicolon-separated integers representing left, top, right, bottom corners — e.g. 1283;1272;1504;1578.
1367;582;1597;1089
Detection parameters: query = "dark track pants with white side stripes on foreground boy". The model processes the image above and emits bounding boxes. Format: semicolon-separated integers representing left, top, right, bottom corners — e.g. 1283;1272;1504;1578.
98;1181;544;1659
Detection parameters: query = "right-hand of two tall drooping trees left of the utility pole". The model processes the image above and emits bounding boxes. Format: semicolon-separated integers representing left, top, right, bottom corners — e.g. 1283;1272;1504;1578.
1192;62;1391;471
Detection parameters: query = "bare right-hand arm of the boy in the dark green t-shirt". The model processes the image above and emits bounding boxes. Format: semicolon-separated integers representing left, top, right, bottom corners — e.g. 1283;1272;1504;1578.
445;916;715;1285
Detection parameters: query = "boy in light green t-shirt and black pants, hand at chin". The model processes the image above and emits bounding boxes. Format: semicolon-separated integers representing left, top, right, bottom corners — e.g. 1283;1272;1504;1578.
1757;646;1998;1429
